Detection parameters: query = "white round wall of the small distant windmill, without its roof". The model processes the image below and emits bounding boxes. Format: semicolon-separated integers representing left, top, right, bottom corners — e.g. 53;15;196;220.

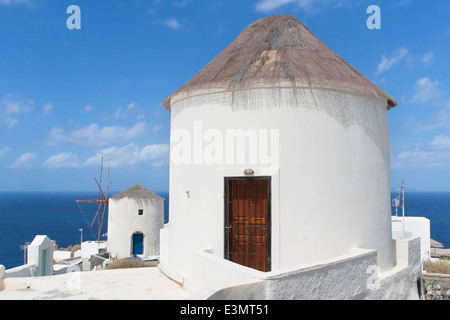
108;197;164;258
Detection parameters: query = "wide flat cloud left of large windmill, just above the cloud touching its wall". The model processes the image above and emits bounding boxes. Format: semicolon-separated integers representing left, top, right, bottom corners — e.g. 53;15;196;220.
49;122;146;146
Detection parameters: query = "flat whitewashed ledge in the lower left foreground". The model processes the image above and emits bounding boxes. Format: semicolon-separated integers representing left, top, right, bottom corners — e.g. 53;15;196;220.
0;268;191;300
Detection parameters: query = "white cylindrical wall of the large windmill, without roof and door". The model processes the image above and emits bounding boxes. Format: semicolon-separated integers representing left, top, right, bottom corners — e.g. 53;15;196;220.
167;88;392;277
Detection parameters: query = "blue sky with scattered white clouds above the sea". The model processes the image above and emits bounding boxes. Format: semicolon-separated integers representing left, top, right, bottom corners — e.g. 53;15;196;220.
0;0;450;191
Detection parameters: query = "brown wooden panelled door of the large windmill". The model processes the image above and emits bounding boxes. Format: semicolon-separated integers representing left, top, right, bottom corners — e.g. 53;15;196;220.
225;177;271;272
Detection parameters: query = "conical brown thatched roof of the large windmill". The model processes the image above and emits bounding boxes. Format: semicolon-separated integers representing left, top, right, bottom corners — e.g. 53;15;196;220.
162;15;397;110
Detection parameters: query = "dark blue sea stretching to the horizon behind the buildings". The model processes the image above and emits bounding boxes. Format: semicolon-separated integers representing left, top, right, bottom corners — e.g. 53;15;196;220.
0;192;450;269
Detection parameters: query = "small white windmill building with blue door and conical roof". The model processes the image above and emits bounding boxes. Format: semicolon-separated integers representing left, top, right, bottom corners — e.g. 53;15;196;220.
108;184;164;259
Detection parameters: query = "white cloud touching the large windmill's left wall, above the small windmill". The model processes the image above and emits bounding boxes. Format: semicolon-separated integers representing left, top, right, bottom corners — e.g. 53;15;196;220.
84;143;169;167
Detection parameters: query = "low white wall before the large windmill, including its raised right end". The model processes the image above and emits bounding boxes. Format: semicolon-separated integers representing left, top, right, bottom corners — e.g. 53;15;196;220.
192;238;422;300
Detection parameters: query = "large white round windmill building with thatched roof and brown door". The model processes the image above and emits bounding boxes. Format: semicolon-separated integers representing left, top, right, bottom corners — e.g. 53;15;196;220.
160;15;422;297
